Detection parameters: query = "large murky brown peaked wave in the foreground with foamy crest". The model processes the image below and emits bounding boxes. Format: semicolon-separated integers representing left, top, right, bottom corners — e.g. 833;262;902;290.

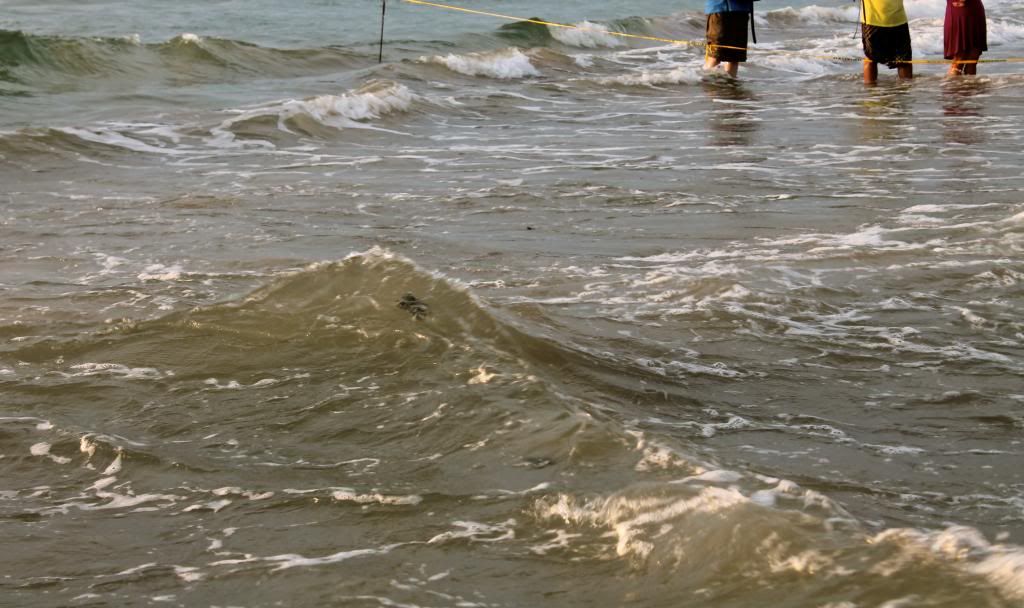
8;249;1024;606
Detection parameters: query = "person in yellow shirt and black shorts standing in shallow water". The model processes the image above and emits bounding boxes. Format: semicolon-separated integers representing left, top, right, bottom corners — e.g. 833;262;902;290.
860;0;913;84
